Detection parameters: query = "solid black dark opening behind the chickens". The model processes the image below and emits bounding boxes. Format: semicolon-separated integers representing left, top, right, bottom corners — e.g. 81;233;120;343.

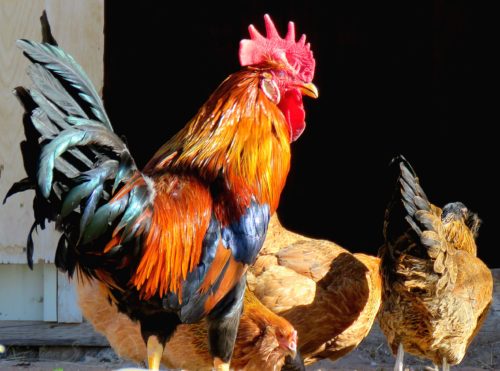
104;1;500;267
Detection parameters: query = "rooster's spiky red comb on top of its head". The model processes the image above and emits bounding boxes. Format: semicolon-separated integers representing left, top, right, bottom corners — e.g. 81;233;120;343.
239;14;316;82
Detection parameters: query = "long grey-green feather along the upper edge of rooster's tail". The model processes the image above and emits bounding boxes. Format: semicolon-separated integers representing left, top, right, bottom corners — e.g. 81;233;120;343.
16;40;113;131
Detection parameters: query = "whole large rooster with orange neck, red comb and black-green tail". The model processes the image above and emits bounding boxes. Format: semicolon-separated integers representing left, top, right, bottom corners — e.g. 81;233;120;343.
3;15;318;370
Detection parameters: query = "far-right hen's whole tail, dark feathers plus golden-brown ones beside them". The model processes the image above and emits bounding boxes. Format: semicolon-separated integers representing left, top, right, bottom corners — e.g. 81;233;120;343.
382;156;457;294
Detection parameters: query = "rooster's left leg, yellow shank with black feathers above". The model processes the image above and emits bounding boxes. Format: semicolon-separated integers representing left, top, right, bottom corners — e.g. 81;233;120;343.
140;312;181;370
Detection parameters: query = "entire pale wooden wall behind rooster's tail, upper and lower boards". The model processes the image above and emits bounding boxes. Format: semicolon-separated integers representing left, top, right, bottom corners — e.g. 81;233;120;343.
0;0;104;322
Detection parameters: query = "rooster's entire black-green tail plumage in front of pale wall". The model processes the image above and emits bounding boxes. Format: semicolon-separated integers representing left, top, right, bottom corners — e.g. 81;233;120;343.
4;39;154;274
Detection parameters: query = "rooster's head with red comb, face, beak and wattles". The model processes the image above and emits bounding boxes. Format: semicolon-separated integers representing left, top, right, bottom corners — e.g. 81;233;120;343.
239;14;318;141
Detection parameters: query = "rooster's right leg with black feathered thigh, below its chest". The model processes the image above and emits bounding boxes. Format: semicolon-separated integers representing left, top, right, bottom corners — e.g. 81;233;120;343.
207;276;246;371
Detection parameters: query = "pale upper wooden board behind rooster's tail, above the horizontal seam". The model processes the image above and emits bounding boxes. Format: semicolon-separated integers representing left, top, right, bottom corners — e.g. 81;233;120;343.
0;0;104;264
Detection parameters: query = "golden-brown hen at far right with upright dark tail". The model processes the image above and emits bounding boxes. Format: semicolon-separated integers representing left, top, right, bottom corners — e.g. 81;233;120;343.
379;157;493;370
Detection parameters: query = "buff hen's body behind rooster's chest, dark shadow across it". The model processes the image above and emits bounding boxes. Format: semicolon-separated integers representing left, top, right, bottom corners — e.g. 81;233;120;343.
248;216;381;369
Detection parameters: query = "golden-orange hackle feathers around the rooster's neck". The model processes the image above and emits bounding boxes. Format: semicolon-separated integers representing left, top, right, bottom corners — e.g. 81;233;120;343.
145;67;290;219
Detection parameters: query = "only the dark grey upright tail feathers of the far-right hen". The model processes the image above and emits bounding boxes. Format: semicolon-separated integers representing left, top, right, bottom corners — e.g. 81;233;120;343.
384;155;431;257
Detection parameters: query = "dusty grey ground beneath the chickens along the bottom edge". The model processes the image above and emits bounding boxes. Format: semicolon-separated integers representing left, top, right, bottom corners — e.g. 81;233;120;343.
0;324;500;371
